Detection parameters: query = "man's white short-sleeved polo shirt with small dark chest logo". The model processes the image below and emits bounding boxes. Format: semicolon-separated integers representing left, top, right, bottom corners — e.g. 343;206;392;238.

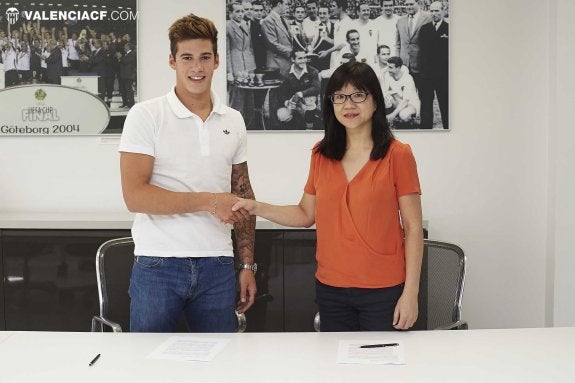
118;89;247;257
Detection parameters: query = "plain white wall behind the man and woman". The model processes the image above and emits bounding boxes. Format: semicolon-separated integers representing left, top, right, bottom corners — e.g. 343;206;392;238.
0;0;575;328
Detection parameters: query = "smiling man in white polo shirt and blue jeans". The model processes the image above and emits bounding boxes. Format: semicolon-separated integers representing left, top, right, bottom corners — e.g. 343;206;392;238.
119;14;256;332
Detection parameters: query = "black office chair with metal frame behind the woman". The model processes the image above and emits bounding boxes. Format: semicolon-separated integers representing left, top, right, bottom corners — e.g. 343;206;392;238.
314;239;468;331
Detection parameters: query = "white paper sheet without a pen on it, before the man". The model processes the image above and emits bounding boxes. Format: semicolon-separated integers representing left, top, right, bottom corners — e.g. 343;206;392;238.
148;336;230;362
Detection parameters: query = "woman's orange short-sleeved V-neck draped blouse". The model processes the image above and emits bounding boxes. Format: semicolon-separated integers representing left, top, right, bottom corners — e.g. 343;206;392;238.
304;140;421;288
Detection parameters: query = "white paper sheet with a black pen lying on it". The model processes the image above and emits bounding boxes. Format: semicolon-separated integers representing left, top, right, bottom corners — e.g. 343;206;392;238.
337;340;405;364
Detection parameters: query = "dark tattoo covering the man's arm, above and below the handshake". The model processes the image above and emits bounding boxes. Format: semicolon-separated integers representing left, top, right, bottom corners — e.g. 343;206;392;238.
232;162;256;263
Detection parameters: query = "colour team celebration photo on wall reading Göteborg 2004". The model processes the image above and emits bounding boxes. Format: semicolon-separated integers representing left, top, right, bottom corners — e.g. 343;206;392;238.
0;0;138;136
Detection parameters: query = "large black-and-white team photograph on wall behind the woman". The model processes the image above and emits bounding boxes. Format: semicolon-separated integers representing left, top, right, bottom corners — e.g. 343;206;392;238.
226;0;449;131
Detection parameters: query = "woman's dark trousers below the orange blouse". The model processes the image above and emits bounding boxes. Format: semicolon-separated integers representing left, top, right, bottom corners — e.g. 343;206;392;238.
315;280;403;332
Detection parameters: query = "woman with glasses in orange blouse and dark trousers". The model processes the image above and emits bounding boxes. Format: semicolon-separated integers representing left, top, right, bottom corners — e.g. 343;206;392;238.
234;62;423;331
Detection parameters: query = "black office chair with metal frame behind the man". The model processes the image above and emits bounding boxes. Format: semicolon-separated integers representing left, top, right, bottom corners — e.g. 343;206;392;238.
92;237;246;332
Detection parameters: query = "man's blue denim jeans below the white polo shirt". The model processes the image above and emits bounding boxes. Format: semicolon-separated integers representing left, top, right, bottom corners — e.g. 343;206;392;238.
129;256;237;332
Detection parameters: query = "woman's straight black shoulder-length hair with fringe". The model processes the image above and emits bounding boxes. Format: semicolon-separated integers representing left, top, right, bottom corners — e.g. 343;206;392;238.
314;62;393;161
